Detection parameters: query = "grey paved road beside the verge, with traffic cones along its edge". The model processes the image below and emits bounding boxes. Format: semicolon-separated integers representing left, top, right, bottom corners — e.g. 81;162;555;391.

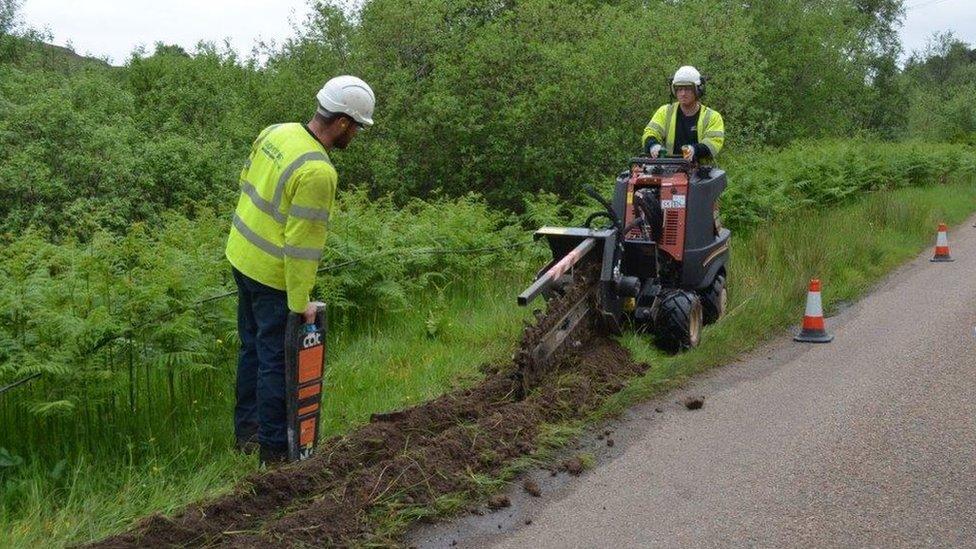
408;216;976;548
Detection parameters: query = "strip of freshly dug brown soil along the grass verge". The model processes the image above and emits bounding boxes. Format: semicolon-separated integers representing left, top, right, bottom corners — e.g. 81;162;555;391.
92;335;648;549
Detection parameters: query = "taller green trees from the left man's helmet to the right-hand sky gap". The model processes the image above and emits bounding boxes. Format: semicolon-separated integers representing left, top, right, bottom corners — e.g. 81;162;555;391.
269;0;916;207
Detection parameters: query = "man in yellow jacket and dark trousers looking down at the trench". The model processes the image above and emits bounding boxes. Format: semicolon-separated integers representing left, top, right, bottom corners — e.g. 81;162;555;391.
226;76;375;464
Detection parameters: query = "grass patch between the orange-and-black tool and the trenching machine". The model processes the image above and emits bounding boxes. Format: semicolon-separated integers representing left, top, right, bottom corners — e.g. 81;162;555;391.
322;275;528;433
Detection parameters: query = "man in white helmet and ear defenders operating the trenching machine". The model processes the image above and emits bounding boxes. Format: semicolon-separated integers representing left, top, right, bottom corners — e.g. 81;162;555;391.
643;65;725;163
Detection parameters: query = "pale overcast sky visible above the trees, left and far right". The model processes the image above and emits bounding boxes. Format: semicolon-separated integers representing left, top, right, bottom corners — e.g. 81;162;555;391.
23;0;976;64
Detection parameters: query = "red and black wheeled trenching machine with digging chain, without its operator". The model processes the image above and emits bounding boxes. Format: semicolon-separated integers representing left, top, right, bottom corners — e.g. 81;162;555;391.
515;157;731;391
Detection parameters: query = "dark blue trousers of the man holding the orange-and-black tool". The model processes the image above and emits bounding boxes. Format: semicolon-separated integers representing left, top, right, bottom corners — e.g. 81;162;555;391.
234;269;288;450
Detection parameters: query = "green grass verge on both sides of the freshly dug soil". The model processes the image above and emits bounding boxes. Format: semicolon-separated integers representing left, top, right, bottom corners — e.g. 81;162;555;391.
0;174;976;547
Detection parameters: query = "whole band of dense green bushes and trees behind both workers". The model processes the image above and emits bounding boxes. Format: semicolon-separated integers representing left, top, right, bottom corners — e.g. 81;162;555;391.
0;0;932;233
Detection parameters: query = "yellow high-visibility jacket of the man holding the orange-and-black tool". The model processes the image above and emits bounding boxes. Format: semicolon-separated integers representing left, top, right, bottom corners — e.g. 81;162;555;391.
226;124;339;313
